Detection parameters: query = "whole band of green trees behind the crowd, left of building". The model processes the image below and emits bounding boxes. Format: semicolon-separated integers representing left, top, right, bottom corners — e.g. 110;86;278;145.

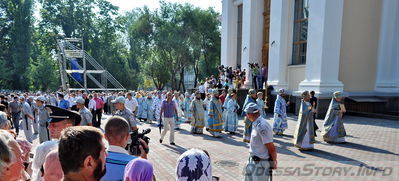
0;0;220;91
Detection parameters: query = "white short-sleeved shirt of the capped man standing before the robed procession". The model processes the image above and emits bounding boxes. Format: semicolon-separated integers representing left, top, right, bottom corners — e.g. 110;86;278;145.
249;116;273;159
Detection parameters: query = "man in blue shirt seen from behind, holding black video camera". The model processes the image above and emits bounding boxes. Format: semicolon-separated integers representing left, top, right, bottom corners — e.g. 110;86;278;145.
101;116;148;181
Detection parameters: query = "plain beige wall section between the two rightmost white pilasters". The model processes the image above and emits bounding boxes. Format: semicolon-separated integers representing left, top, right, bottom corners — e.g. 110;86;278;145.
339;0;382;92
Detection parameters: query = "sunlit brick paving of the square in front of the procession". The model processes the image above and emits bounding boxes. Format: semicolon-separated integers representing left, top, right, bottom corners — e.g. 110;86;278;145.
25;116;399;181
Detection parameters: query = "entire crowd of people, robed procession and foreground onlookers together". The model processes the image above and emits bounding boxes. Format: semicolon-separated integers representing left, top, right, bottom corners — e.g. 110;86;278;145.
0;88;346;181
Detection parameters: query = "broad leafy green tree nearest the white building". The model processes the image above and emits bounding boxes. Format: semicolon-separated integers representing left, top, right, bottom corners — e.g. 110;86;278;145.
126;1;220;91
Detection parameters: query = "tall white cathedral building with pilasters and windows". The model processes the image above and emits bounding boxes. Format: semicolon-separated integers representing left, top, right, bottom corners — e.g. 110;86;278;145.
221;0;399;116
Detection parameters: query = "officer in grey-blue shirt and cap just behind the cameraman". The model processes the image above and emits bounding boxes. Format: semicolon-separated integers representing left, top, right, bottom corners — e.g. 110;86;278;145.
111;96;138;132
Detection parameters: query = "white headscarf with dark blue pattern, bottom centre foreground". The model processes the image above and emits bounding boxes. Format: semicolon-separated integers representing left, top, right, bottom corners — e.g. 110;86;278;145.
176;148;212;181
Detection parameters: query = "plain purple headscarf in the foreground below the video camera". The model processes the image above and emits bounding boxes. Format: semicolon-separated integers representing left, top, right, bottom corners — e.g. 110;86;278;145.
123;158;153;181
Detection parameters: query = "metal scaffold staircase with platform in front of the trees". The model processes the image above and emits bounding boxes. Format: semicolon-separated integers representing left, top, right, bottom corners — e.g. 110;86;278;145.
57;38;126;91
